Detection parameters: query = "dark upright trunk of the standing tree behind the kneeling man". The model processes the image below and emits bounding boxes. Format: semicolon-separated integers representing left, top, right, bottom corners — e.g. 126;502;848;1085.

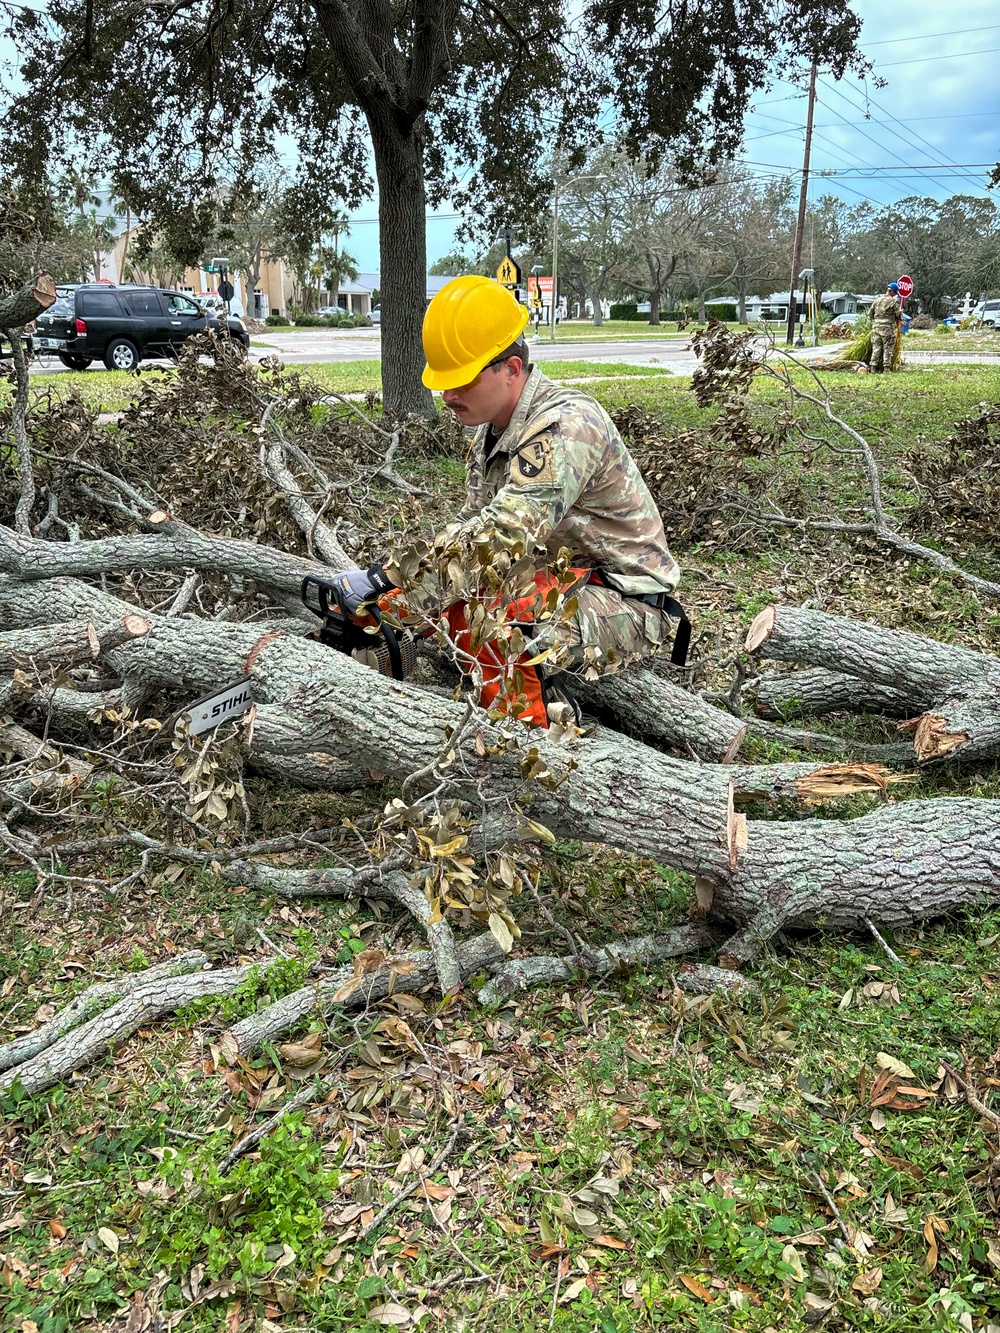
368;112;435;417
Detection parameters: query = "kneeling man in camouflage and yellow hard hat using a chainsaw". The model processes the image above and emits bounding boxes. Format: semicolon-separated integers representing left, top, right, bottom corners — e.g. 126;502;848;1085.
333;277;687;725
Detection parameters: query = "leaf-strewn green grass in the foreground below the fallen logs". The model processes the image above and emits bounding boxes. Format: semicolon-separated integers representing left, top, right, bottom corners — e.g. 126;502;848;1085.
3;863;1000;1333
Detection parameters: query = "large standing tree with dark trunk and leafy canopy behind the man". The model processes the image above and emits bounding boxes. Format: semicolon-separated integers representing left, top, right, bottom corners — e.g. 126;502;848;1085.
0;0;861;415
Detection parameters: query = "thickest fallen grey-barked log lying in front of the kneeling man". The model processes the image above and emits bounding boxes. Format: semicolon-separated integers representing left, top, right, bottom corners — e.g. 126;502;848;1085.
0;567;1000;960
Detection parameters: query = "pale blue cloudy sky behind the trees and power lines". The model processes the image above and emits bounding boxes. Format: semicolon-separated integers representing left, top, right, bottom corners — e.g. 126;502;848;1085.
4;0;1000;272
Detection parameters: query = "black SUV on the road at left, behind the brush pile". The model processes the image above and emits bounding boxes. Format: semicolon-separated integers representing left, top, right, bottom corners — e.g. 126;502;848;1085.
35;283;249;371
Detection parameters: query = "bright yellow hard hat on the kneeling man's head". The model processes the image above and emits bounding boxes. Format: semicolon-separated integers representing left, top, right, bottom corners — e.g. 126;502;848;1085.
424;273;531;389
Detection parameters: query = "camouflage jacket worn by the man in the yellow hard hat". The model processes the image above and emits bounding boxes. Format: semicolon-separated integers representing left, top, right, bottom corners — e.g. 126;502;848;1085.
459;367;680;595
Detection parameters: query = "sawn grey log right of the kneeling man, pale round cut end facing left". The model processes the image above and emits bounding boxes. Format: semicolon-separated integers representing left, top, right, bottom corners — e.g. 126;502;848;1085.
747;607;1000;765
